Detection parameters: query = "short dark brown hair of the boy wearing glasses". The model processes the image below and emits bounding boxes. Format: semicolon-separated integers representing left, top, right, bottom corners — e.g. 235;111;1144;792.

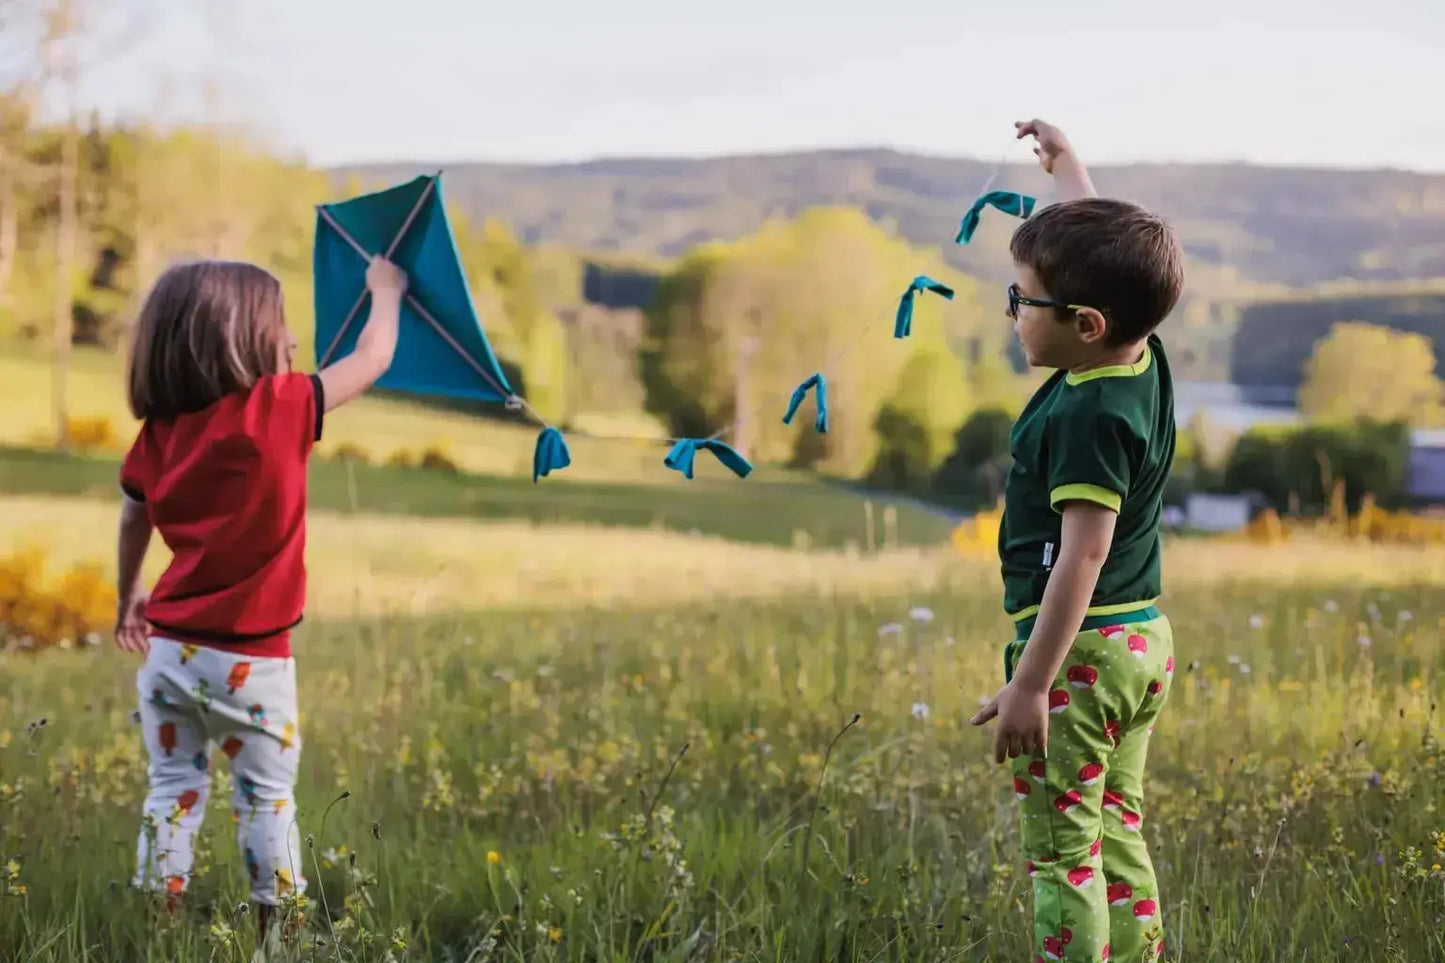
1009;197;1183;344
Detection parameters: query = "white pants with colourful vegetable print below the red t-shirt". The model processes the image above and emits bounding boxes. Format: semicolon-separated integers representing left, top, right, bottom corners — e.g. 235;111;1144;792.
134;638;306;905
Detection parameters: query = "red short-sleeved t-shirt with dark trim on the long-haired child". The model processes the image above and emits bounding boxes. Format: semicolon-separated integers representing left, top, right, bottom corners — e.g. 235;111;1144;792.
120;375;325;656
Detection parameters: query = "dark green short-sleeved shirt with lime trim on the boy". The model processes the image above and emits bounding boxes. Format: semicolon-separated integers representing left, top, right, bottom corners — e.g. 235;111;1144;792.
998;335;1175;638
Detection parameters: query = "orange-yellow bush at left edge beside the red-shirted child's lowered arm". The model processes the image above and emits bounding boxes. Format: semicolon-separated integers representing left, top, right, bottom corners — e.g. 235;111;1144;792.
0;549;116;651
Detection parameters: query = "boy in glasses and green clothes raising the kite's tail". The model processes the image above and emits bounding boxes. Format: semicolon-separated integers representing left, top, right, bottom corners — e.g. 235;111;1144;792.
972;120;1183;963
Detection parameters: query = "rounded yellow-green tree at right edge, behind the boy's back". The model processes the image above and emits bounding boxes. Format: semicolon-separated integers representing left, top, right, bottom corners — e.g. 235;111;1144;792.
1299;321;1445;425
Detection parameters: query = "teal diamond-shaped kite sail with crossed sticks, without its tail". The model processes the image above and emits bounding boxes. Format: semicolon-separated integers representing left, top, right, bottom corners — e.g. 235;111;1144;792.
314;174;513;402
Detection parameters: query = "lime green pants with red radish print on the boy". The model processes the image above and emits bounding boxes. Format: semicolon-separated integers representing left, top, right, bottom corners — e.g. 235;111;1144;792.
1007;616;1173;963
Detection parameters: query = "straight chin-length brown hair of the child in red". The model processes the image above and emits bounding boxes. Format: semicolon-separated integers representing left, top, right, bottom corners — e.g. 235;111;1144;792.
127;260;286;419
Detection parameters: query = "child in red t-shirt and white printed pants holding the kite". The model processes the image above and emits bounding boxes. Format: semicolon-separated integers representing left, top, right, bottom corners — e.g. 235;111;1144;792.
116;259;406;940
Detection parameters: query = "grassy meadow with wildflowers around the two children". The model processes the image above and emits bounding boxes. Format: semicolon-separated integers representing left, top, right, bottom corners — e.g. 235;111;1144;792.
0;348;1445;963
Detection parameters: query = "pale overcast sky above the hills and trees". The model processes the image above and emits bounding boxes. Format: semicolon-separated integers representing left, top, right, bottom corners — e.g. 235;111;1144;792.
62;0;1445;171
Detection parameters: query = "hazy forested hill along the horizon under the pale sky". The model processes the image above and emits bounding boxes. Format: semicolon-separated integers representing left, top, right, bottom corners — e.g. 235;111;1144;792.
335;150;1445;290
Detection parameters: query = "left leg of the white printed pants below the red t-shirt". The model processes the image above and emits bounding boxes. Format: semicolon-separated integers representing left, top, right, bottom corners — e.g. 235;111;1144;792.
134;648;210;896
